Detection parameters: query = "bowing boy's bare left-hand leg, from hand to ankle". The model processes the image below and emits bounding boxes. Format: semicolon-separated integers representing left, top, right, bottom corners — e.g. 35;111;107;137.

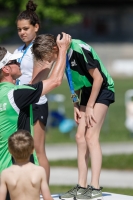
76;106;89;187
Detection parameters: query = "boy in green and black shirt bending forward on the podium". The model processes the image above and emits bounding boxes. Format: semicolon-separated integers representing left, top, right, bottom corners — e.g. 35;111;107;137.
33;34;115;200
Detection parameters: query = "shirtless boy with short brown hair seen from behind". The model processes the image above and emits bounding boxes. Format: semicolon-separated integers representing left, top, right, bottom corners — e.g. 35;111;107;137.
0;130;53;200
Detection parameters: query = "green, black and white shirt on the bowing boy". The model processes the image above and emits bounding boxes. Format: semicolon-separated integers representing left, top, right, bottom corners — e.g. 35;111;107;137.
68;39;114;92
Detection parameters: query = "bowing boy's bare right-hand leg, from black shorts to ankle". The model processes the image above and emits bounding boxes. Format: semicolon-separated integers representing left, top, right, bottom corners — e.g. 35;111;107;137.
86;103;108;189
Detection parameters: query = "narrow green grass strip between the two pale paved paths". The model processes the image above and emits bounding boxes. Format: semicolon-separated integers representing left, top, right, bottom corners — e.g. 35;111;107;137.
50;154;133;170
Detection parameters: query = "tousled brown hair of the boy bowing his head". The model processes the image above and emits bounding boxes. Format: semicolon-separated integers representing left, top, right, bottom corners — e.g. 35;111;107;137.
32;34;57;60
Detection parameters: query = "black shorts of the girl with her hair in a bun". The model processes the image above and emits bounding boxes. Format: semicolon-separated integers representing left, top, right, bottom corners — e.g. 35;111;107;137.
32;102;48;126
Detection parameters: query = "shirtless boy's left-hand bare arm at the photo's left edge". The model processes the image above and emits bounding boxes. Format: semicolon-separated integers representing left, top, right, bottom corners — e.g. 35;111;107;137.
0;172;7;200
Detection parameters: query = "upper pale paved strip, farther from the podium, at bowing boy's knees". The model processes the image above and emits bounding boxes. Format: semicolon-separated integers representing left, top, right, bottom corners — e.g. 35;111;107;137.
46;142;133;160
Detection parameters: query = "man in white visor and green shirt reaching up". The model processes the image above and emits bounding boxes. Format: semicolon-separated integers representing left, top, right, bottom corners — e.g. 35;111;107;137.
0;33;71;199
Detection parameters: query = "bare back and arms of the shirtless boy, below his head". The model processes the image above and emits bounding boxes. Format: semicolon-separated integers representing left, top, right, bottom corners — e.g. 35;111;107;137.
1;162;52;200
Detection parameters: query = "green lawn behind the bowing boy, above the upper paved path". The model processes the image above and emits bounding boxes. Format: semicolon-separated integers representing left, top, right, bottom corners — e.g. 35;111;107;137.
47;78;133;143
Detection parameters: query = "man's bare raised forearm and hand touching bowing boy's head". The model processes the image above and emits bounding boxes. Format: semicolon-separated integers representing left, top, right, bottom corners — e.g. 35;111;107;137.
42;33;71;95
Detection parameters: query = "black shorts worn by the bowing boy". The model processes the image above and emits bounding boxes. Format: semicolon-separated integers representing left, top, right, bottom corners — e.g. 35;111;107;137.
80;87;115;106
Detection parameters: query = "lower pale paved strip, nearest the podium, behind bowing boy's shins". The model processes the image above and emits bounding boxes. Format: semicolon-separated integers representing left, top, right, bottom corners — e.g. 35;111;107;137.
50;167;133;188
